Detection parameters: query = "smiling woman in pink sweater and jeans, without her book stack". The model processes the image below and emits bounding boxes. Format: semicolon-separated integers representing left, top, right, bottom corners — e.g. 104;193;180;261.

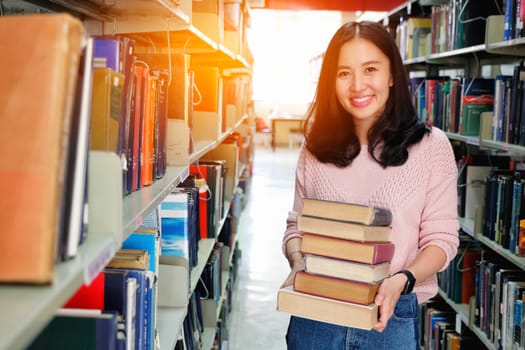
283;22;459;350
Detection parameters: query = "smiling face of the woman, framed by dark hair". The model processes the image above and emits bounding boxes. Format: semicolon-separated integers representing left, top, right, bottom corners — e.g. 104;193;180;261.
335;37;392;130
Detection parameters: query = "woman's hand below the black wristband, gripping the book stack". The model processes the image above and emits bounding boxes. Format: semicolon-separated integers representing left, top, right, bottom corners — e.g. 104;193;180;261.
374;274;407;332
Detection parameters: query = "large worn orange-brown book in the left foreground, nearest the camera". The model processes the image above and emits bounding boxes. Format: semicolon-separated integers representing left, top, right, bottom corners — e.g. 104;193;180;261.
0;14;84;283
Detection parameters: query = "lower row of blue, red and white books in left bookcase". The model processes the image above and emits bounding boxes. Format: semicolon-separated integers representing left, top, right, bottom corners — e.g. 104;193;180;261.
29;165;242;349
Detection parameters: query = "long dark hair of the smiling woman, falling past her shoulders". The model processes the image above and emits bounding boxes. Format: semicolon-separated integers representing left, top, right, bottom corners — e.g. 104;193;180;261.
304;22;430;167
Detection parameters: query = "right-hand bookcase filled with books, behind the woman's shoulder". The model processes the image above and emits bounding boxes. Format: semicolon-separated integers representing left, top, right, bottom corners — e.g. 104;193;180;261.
384;1;525;349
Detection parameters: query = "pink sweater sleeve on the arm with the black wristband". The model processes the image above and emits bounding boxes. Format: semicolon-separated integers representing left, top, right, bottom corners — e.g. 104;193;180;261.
419;129;459;271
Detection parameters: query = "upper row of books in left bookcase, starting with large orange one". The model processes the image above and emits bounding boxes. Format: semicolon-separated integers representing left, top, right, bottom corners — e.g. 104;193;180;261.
0;14;249;284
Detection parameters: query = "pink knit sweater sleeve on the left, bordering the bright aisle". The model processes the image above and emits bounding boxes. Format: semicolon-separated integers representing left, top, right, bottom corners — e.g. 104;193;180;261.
282;144;307;255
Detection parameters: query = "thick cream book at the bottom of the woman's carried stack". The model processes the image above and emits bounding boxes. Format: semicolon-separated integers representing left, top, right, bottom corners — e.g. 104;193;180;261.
277;287;378;330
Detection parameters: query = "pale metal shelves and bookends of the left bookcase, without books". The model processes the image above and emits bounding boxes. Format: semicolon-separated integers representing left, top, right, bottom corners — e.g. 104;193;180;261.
0;0;252;350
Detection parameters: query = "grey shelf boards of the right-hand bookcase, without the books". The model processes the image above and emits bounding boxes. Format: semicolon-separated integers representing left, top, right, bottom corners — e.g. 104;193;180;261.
383;0;525;349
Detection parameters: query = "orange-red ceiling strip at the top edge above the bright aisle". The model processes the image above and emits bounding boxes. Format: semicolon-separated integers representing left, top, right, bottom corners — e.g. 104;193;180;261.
250;0;406;11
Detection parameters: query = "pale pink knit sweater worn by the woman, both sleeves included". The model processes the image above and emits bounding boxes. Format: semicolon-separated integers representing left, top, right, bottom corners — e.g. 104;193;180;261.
283;128;459;303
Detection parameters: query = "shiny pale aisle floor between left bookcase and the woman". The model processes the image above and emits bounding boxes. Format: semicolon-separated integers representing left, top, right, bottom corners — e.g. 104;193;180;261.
228;146;298;350
